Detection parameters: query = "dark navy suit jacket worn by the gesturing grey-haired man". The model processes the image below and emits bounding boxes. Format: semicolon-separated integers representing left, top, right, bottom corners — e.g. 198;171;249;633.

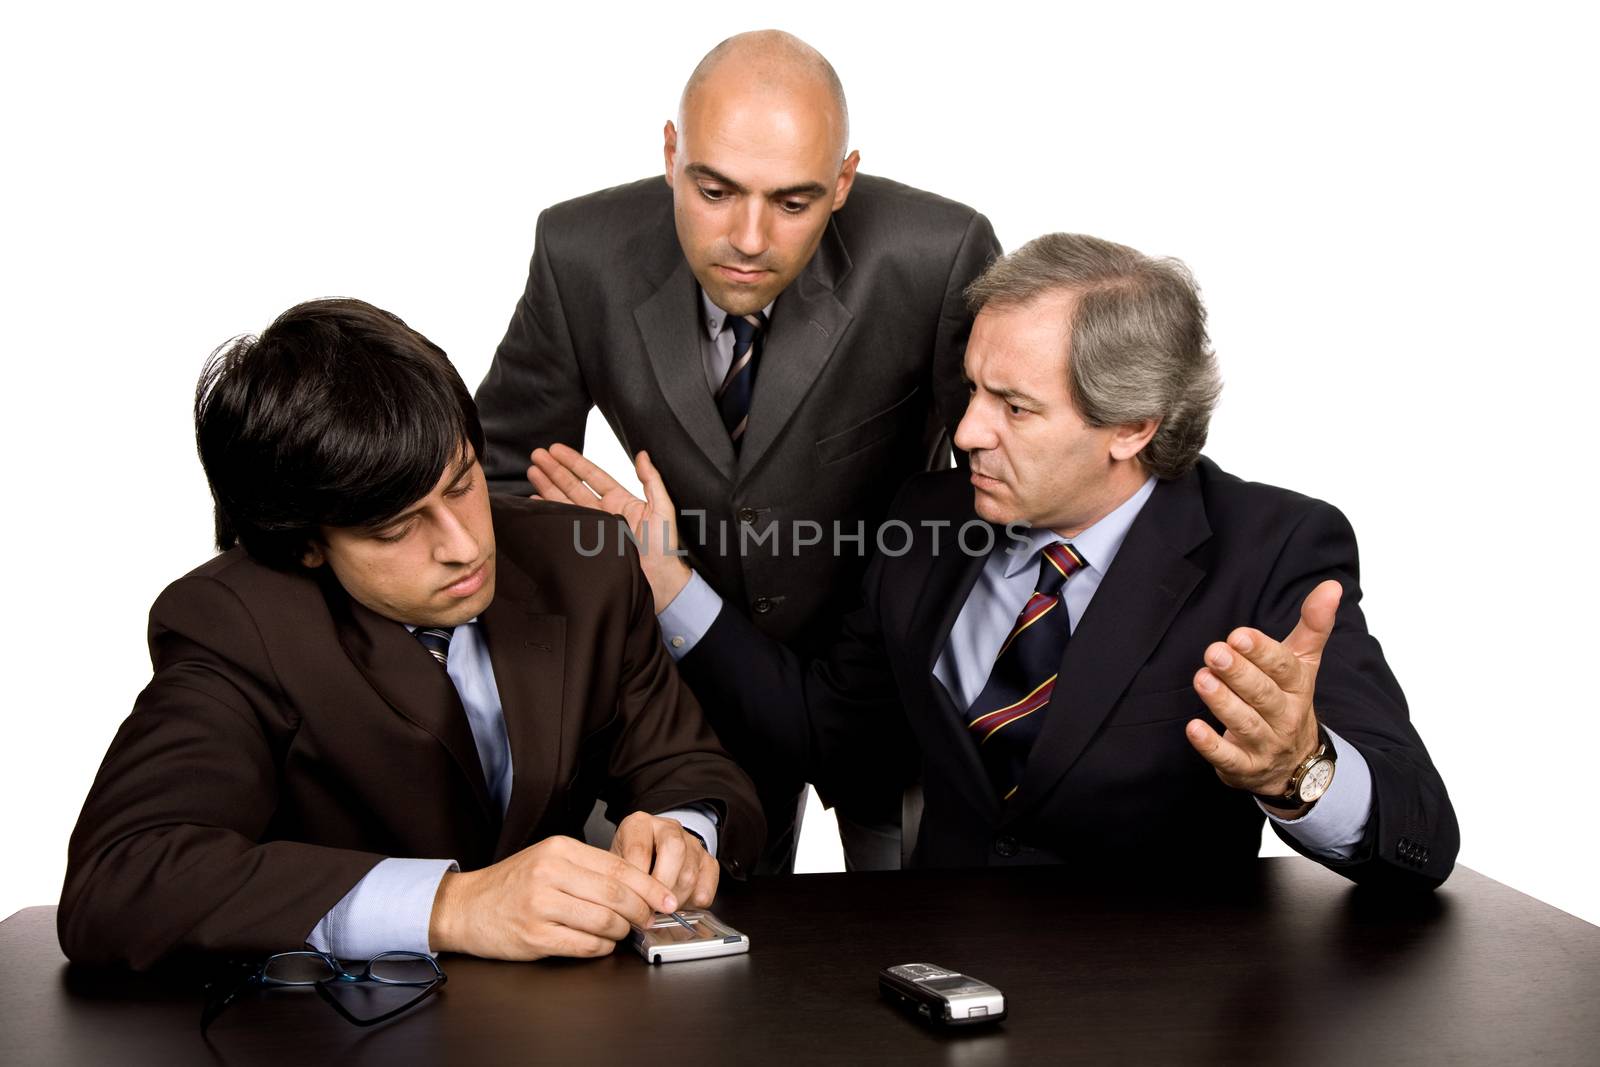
678;459;1459;885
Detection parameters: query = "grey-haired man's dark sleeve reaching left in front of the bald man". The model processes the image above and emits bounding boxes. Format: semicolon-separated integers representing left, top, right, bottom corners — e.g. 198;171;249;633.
678;537;918;805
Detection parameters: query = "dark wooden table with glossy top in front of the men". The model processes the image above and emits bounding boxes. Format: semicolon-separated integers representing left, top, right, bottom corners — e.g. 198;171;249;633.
0;857;1600;1067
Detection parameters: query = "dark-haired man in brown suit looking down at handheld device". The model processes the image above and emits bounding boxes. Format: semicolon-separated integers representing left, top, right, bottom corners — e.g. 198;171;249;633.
59;301;763;968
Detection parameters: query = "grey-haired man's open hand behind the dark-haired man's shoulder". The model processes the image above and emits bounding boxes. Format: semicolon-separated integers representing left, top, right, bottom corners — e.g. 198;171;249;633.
528;445;691;614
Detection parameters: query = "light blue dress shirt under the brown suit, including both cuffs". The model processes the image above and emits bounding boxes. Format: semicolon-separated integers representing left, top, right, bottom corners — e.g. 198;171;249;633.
306;619;717;960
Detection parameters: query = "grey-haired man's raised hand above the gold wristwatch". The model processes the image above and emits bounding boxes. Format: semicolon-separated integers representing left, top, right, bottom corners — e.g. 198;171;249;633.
1184;581;1344;814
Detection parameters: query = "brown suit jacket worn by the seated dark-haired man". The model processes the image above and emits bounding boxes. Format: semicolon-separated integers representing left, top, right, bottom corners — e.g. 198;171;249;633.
58;498;765;969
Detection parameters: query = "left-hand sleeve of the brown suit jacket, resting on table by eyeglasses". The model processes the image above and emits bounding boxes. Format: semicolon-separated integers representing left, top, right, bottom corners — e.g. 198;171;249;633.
58;577;382;969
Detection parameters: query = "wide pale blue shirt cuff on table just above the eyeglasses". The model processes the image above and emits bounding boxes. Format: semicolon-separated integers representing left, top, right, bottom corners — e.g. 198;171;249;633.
306;857;461;960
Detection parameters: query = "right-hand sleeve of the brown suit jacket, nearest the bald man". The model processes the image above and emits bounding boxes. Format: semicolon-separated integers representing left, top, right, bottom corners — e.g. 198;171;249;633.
605;534;766;875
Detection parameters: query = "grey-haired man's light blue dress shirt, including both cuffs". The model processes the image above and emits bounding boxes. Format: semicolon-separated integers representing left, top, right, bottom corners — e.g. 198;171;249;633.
658;477;1373;859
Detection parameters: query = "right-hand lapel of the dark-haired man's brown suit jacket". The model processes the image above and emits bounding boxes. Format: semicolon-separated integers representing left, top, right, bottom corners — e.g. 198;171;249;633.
480;555;566;859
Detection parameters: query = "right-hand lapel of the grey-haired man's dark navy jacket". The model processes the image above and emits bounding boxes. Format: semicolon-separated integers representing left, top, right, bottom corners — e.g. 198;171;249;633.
1003;472;1211;824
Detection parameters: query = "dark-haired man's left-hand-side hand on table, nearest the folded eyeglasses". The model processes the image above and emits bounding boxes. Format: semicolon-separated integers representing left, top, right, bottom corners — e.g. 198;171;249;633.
427;837;678;960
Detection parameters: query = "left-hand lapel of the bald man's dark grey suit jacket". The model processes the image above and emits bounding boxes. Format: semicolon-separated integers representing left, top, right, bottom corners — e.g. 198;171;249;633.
634;256;739;482
